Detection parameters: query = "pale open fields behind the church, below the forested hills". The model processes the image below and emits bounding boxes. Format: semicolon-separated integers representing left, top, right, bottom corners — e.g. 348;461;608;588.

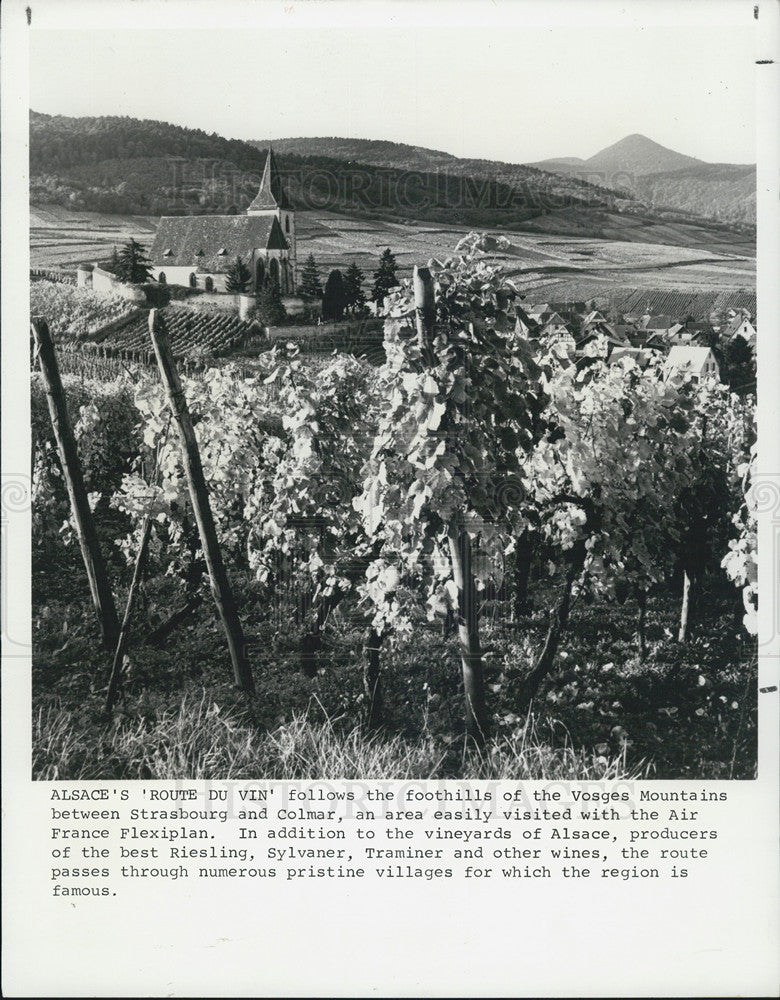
30;206;755;320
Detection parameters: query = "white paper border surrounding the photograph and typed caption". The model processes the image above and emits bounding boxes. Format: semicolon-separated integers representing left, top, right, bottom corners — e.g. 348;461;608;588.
0;0;780;997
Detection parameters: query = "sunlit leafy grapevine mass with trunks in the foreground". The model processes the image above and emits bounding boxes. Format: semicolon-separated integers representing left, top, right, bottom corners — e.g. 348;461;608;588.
64;259;755;741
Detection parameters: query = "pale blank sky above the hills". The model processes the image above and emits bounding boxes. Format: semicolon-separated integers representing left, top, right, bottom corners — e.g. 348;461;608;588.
30;0;755;163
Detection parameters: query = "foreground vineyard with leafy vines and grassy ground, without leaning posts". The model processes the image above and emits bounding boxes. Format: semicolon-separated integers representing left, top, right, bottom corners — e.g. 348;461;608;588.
32;250;756;779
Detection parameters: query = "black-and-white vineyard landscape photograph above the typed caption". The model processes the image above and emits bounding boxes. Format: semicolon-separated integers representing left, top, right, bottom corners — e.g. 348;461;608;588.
24;5;763;780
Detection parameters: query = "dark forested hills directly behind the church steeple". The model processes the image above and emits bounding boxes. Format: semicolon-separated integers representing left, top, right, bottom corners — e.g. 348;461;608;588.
30;111;748;244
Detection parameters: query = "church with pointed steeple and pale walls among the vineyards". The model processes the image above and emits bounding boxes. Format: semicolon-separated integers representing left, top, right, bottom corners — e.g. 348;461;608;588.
149;149;296;295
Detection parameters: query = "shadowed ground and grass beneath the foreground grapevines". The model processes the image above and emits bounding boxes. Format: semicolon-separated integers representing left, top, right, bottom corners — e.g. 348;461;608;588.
32;528;757;781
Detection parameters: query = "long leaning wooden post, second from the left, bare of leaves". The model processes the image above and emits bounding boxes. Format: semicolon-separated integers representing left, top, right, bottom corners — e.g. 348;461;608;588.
149;309;255;694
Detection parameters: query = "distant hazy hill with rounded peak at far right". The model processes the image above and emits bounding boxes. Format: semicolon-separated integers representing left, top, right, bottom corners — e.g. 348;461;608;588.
531;135;756;226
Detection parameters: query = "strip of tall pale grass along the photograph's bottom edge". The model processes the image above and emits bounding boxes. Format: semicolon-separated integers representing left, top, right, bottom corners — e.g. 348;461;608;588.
33;691;646;781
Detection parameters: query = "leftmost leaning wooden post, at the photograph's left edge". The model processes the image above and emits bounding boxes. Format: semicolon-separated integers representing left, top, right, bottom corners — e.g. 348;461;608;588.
31;318;119;649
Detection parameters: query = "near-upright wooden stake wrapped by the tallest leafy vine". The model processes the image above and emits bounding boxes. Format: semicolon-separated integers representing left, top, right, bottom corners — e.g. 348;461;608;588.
413;267;488;746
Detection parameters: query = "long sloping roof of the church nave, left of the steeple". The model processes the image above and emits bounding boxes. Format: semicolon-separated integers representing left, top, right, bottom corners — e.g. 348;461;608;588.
149;215;289;274
